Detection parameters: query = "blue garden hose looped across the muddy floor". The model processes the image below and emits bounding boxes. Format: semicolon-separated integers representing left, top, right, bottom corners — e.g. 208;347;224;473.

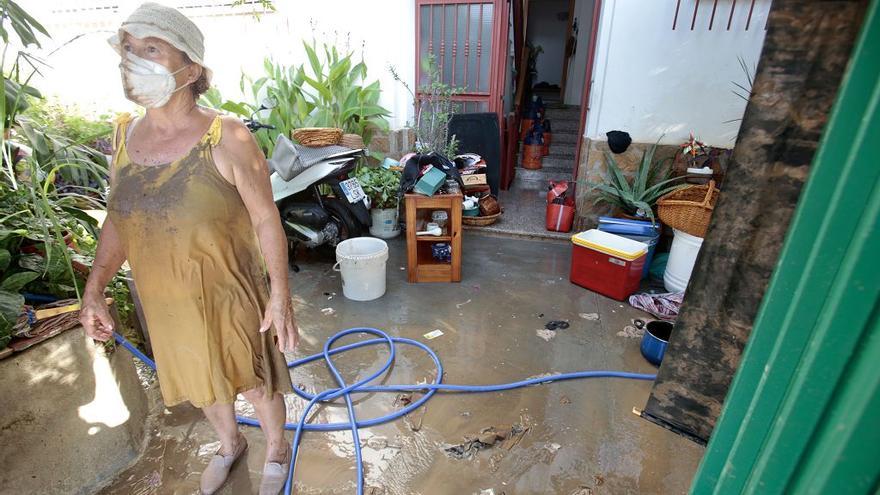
113;328;657;495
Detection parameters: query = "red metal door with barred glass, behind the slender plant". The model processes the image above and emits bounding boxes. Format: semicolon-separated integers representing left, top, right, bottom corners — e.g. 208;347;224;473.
416;0;508;116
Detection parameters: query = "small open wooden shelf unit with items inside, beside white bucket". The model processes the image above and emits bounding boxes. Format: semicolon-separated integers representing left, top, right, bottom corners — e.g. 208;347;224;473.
405;194;463;283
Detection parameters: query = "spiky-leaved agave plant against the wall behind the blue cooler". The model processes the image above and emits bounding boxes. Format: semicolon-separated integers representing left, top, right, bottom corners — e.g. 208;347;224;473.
591;141;687;222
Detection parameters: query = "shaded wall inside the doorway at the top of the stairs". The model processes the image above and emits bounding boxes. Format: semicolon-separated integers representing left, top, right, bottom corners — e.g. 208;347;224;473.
526;0;568;84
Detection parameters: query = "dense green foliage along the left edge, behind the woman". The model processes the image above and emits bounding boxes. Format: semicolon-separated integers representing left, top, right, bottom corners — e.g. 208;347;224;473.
0;0;130;349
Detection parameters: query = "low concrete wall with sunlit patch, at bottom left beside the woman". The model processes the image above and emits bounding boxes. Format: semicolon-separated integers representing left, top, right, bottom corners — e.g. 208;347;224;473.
0;327;151;494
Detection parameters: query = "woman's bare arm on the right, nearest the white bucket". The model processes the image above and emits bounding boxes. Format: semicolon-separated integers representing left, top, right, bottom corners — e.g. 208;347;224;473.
214;118;299;352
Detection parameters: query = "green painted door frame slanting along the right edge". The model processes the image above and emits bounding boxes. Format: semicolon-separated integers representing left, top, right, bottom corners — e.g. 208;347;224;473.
691;0;880;495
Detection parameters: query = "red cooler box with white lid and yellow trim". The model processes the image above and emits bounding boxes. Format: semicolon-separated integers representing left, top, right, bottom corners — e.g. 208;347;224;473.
569;229;648;301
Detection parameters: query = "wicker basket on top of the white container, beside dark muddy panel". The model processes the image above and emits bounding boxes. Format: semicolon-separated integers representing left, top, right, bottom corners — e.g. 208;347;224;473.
657;181;721;237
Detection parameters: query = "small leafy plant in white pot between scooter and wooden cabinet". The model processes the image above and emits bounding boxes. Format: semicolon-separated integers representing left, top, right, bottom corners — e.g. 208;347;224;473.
356;165;400;239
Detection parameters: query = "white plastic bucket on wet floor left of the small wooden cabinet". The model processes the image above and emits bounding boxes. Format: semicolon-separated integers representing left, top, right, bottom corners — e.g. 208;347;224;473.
333;237;388;301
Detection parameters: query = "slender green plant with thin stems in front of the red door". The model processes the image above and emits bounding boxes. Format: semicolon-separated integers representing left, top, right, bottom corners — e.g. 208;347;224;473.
388;54;461;158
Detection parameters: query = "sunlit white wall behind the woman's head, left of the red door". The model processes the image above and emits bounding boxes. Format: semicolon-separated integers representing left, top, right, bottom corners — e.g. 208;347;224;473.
20;0;415;127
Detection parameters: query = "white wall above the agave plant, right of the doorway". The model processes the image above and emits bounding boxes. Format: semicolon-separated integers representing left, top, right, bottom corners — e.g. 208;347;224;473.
585;0;770;147
